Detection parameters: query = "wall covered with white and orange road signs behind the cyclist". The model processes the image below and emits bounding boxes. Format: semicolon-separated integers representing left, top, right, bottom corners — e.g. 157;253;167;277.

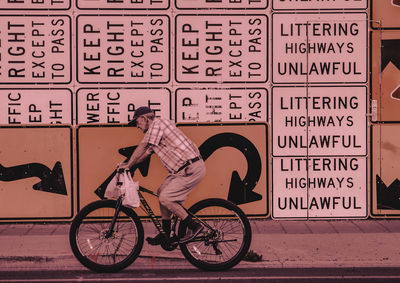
0;0;400;220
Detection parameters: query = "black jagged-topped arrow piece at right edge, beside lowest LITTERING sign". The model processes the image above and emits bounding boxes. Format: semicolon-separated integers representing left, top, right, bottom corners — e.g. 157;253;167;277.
376;175;400;209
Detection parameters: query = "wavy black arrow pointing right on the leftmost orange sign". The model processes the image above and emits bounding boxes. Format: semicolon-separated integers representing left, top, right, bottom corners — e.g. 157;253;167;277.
0;161;67;195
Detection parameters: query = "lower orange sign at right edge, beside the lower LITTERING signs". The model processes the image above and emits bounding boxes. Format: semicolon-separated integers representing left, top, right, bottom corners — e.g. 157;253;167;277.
371;123;400;217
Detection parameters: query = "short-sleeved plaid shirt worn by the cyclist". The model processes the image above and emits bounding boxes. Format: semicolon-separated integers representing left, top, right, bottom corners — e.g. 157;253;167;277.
143;118;200;173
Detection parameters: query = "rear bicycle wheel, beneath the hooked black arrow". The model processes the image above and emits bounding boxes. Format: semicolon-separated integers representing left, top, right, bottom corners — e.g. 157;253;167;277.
178;199;252;271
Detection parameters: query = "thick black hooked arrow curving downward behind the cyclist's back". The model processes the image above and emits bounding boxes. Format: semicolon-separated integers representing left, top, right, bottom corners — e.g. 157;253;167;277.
199;133;262;204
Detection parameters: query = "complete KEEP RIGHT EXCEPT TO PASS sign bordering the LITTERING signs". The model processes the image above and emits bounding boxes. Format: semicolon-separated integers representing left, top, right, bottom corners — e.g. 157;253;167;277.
175;14;268;83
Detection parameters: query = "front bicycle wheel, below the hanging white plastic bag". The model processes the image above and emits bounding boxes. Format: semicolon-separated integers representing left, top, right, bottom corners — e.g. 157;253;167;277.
69;200;144;272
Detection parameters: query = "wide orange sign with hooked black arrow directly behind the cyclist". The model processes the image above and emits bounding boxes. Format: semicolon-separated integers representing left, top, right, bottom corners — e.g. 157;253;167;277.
77;123;269;216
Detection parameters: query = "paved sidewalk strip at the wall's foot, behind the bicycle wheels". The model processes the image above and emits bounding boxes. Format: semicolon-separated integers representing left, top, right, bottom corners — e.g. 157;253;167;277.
0;219;400;271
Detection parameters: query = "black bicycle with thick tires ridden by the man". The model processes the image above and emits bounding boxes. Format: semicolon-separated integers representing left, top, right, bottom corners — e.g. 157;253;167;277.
69;168;252;272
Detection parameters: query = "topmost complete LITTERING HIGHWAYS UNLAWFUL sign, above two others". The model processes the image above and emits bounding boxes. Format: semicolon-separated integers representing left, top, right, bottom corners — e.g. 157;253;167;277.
272;13;368;84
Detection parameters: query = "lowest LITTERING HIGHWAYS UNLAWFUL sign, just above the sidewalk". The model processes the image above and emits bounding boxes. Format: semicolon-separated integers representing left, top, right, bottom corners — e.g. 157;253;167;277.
272;156;368;219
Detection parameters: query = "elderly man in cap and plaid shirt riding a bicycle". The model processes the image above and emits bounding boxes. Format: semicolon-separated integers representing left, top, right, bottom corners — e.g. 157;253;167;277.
118;107;206;245
